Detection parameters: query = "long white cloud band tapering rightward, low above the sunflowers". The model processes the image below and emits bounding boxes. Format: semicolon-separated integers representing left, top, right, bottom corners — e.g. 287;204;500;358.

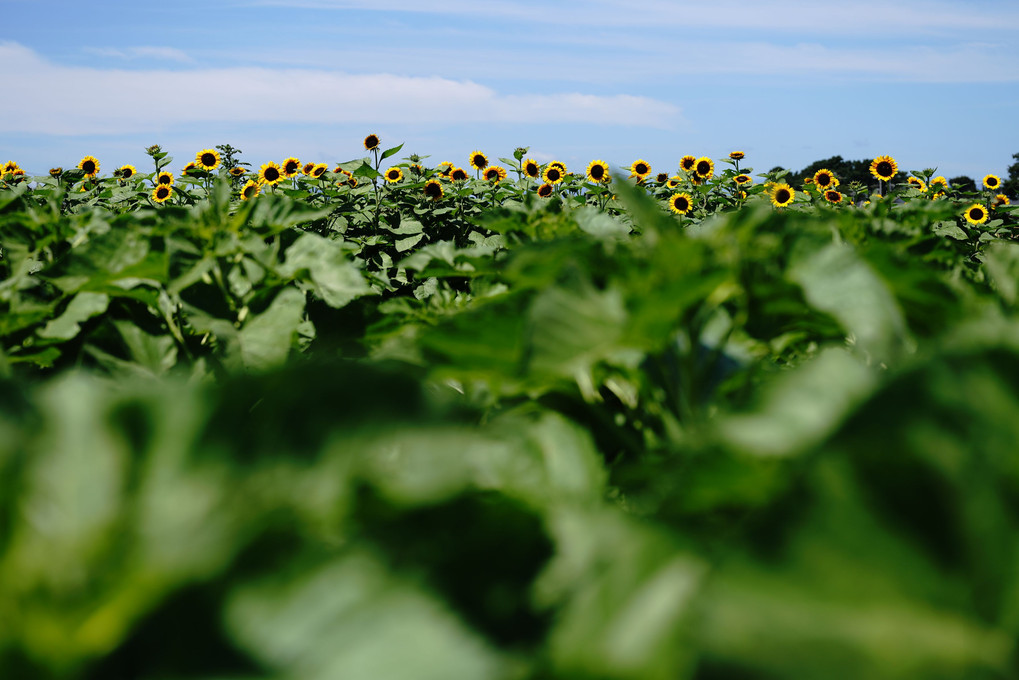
0;43;682;135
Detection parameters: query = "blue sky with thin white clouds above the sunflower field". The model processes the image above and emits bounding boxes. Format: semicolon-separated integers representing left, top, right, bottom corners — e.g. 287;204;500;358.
0;0;1019;177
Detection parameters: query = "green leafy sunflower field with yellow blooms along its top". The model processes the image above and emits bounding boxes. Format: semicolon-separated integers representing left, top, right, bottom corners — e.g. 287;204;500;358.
0;139;1019;680
